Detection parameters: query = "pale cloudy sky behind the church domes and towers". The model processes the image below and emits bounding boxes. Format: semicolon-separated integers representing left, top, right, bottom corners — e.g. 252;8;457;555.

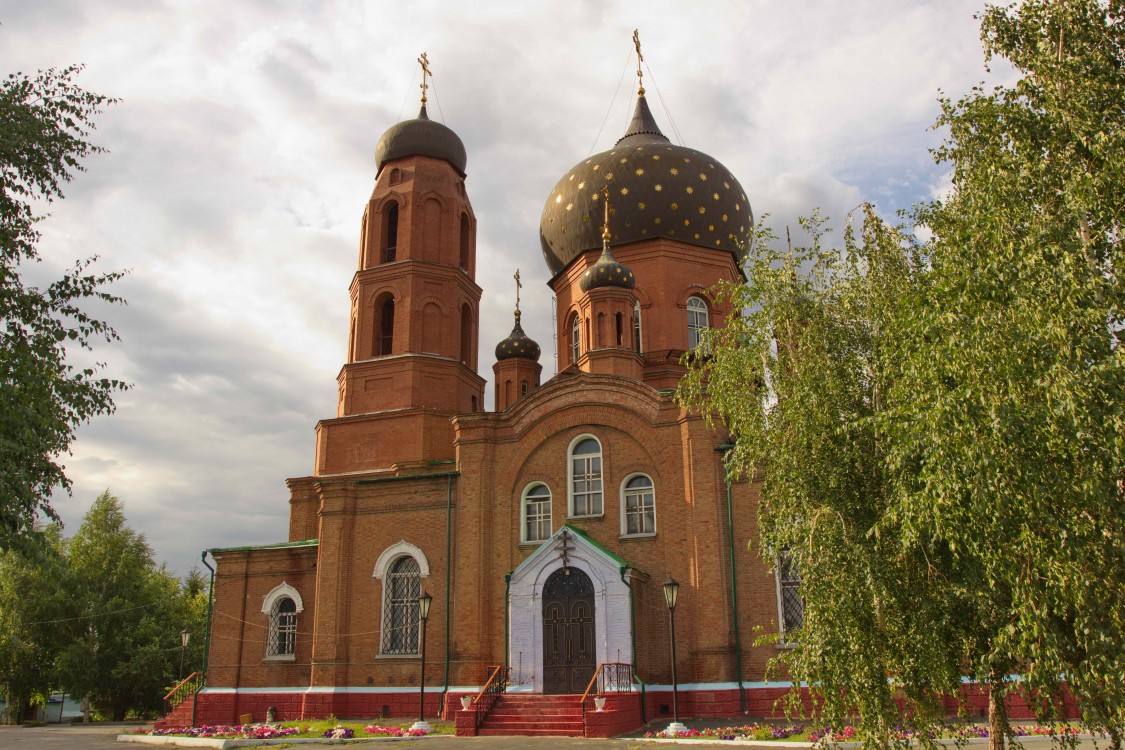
0;0;1002;572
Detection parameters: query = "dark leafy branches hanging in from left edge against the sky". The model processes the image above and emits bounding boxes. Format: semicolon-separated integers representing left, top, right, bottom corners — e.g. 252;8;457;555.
0;66;125;550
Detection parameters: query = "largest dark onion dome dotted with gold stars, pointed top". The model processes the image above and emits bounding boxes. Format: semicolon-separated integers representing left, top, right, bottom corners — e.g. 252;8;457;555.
539;94;754;274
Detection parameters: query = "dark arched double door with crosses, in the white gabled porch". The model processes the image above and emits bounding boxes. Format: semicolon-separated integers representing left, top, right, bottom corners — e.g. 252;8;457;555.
543;568;596;695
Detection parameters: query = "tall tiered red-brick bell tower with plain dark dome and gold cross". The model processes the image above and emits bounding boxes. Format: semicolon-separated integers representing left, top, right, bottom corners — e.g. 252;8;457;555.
315;54;485;476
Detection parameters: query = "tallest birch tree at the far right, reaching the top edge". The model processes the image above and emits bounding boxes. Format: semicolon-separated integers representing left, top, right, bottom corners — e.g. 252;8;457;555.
885;0;1125;743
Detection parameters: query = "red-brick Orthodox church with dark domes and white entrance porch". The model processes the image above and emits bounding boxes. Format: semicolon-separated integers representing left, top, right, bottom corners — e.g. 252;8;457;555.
188;54;801;734
